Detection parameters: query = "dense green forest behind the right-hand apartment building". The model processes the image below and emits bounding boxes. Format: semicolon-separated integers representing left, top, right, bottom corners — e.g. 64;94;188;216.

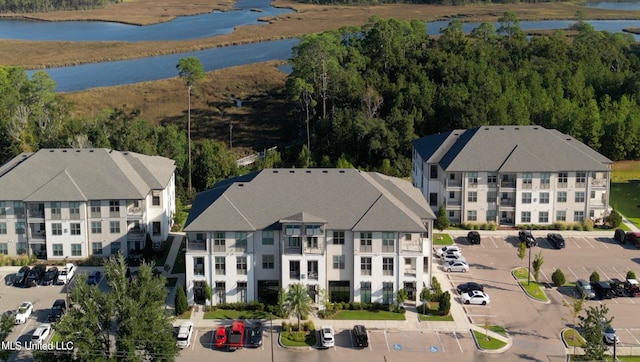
287;12;640;176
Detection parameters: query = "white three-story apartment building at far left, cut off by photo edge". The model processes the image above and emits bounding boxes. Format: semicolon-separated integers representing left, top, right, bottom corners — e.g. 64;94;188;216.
0;148;175;259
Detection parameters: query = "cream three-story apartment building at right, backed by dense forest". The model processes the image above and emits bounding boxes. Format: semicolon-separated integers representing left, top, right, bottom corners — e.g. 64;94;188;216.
412;126;612;225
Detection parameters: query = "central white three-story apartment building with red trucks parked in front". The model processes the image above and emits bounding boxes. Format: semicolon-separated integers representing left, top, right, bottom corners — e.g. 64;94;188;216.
184;169;435;304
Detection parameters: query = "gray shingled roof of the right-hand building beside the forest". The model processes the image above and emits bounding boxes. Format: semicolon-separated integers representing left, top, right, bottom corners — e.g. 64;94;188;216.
413;126;612;172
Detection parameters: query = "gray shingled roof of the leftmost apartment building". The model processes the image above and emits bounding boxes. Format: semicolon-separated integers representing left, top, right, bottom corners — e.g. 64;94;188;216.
0;148;175;202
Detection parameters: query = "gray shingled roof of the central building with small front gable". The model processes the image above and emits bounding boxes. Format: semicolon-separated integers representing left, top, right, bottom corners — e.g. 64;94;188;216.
185;169;435;232
